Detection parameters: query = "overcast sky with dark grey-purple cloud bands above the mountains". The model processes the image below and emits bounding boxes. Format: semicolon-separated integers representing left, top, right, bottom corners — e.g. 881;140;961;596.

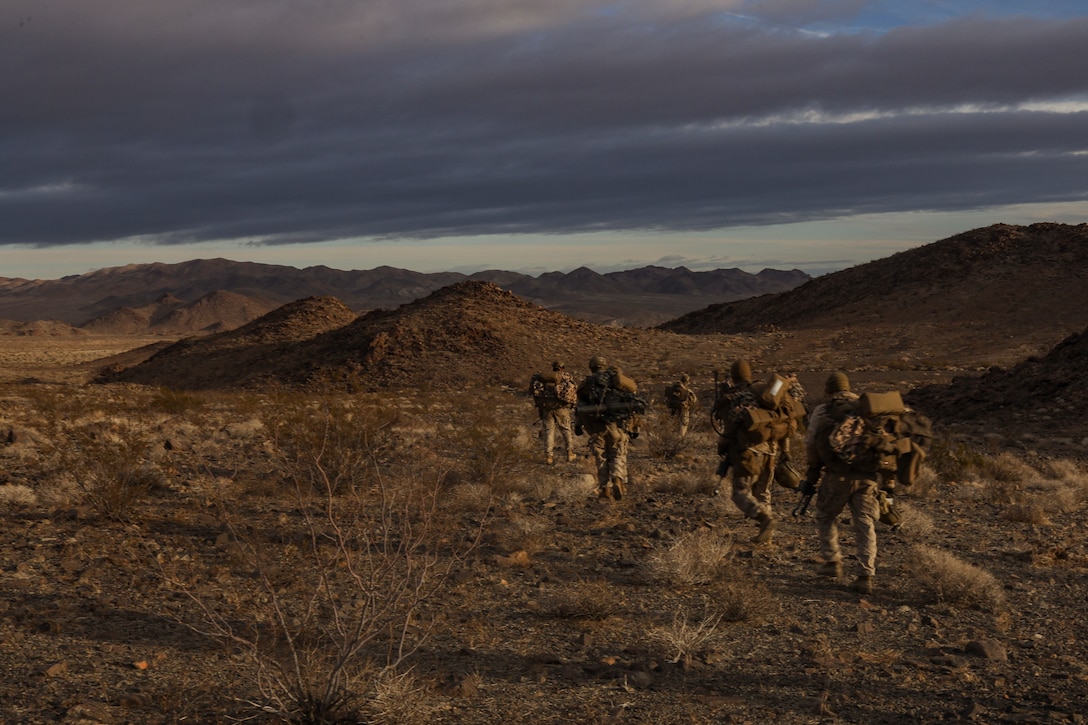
0;0;1088;279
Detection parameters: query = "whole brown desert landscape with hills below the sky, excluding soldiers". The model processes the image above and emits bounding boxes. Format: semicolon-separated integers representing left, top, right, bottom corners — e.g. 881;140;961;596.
0;224;1088;725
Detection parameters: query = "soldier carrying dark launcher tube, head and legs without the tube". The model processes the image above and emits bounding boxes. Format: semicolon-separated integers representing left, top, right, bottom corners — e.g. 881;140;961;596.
574;355;638;501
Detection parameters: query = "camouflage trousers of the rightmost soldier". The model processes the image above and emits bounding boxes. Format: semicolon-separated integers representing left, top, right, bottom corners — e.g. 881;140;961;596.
816;472;880;577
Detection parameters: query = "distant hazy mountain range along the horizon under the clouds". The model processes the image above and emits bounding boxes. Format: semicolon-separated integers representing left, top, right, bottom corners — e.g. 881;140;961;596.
0;259;811;334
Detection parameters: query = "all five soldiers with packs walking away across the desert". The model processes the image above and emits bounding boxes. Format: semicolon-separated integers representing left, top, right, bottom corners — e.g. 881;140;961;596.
530;355;928;593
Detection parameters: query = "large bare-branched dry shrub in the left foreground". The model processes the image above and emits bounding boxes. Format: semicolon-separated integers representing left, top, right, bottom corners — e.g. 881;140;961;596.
157;397;486;725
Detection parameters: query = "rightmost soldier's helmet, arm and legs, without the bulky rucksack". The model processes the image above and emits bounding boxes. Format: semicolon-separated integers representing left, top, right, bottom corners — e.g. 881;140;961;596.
805;372;880;593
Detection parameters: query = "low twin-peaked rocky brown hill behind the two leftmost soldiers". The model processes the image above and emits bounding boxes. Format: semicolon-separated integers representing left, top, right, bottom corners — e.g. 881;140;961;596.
101;281;739;390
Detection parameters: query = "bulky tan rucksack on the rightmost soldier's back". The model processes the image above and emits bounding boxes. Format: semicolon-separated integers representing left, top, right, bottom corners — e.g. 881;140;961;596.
816;391;932;486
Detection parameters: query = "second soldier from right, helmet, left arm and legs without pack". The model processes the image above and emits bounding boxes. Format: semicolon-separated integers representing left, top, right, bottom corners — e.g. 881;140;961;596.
714;359;780;543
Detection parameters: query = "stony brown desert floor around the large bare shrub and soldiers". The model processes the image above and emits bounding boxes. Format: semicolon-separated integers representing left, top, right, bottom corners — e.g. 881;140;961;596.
0;371;1088;724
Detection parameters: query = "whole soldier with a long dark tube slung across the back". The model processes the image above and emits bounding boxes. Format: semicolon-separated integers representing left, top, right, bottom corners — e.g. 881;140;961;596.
574;355;646;501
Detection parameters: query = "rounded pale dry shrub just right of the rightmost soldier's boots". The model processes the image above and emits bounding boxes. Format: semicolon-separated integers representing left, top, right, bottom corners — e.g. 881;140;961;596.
905;544;1005;612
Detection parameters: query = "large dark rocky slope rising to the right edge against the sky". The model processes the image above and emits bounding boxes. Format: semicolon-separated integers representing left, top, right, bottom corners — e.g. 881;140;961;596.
660;223;1088;367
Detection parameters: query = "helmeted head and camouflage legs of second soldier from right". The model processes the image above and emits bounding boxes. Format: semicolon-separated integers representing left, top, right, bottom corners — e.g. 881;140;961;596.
718;359;780;543
